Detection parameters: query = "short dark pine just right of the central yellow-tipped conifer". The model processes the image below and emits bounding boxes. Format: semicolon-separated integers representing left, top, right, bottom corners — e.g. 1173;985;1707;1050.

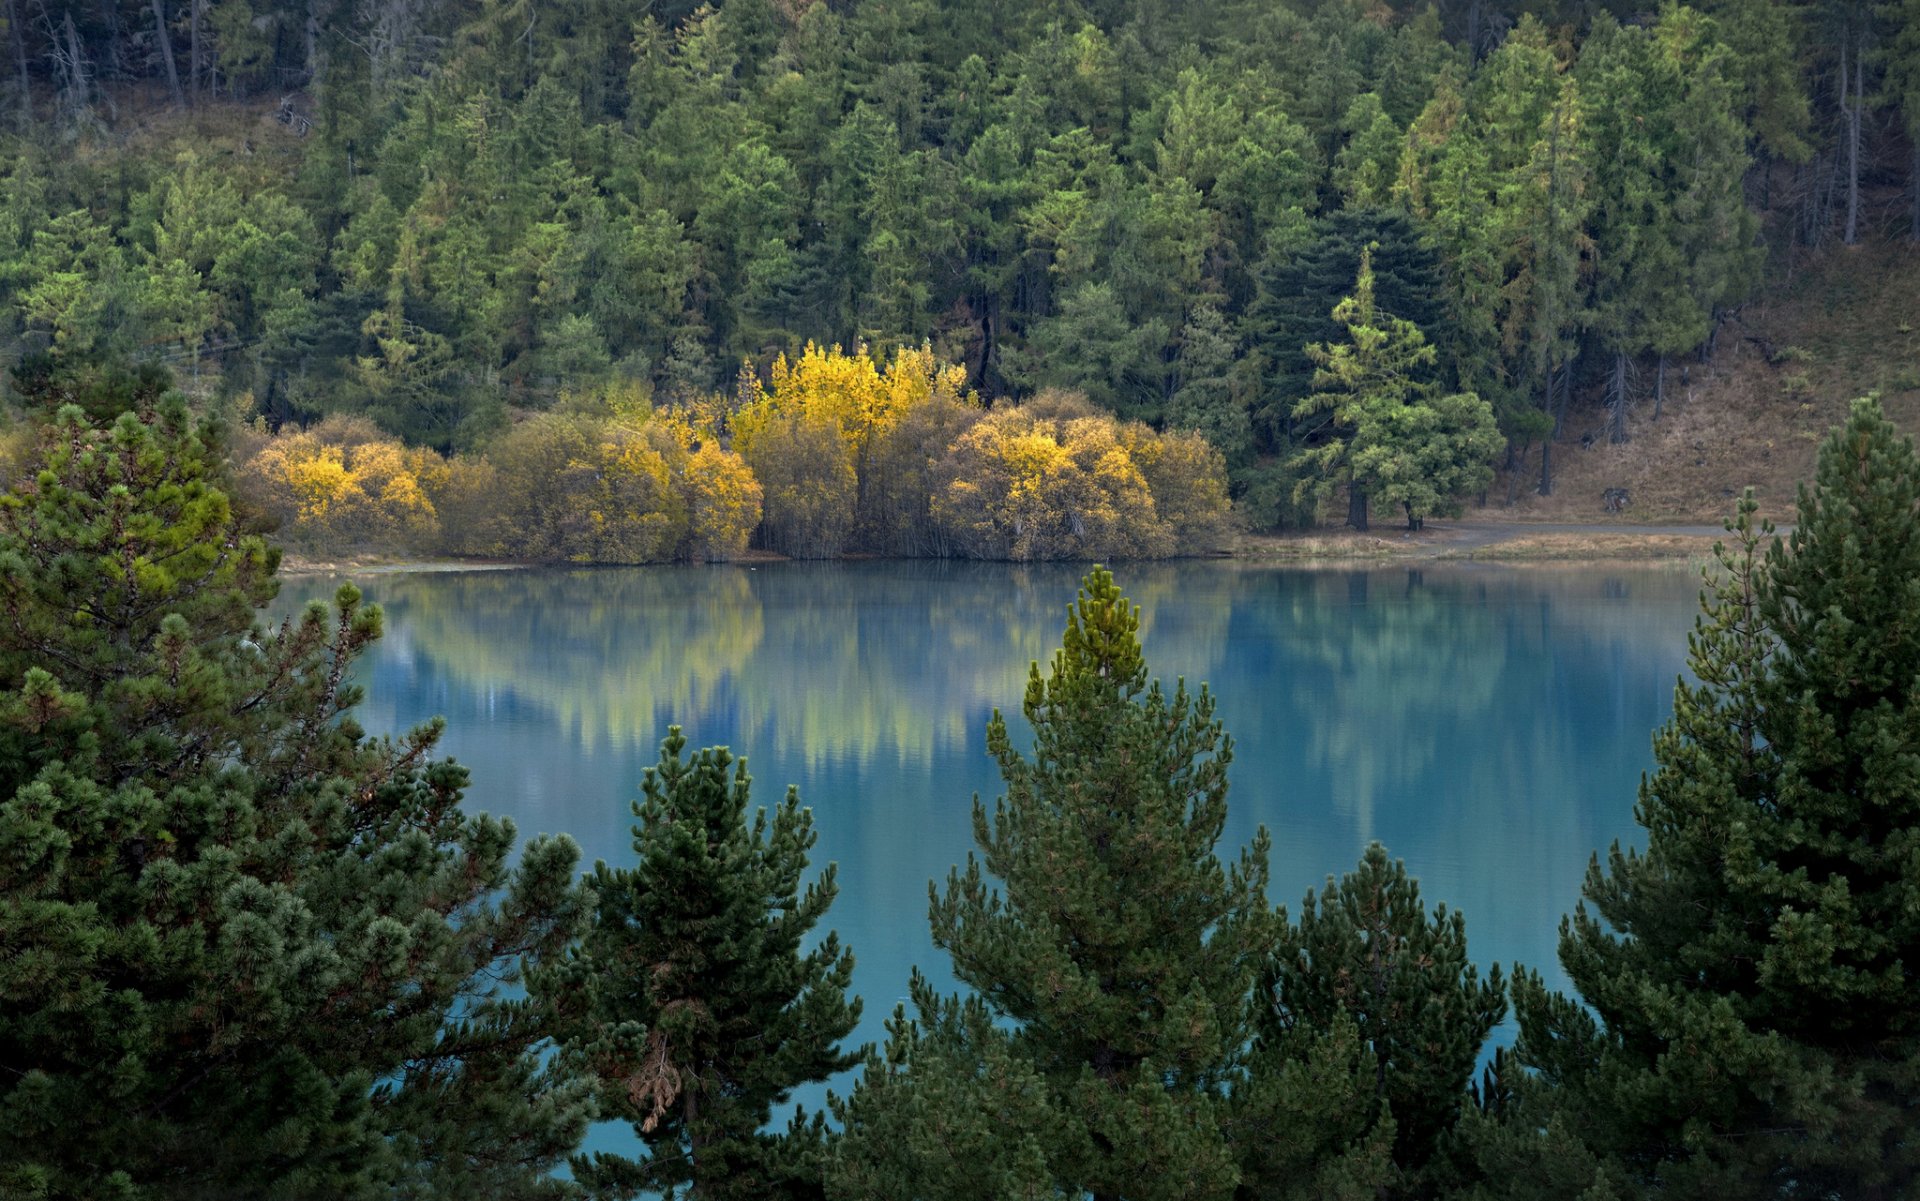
1261;842;1507;1197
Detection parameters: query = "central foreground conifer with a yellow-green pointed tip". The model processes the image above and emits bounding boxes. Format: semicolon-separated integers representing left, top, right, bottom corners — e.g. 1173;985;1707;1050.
829;568;1382;1201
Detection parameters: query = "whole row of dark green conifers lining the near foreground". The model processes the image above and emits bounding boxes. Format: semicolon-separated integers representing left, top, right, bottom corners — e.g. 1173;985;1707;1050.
0;387;1920;1201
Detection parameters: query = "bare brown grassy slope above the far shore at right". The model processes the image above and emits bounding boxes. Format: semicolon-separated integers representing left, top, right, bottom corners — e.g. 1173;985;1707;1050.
1475;244;1920;522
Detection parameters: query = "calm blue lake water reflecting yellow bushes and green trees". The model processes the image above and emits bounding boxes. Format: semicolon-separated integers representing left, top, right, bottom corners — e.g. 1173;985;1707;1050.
278;562;1697;1128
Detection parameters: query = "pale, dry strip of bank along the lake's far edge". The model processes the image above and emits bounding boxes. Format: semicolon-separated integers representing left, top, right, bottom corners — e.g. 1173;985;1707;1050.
280;522;1726;577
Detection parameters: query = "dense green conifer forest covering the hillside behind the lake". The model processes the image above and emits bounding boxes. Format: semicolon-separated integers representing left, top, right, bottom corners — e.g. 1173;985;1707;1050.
0;0;1920;526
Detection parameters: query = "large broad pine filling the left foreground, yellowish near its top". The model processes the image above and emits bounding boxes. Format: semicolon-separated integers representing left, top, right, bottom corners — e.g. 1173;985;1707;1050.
0;395;588;1199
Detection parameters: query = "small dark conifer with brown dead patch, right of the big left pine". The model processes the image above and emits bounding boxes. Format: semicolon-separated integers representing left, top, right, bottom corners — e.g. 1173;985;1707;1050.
536;727;860;1201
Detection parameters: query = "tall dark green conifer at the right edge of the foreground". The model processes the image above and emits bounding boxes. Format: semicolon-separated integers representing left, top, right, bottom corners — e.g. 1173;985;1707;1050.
1515;401;1920;1197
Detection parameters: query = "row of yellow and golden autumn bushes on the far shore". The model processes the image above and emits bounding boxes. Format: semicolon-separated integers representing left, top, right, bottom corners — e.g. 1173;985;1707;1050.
240;345;1231;564
